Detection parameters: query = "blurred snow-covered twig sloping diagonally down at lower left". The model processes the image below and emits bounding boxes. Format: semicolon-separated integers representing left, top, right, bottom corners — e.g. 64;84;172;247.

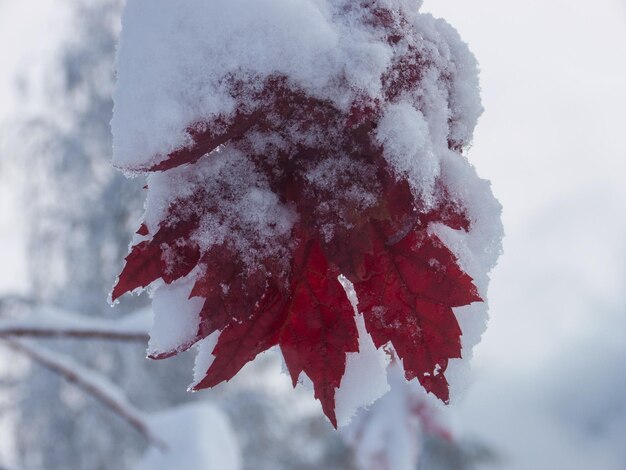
2;338;167;450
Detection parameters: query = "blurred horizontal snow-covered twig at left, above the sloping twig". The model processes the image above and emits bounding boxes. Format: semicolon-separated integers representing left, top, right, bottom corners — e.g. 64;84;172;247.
0;307;151;343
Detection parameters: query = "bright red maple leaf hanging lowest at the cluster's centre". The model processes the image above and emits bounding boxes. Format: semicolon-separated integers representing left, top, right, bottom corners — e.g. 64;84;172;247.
195;233;358;426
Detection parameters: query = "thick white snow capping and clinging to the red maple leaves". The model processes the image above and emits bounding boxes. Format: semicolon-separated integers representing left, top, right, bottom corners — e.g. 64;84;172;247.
111;0;502;423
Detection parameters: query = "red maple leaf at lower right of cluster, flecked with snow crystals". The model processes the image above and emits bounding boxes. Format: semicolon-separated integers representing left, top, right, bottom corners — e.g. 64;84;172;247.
354;224;481;402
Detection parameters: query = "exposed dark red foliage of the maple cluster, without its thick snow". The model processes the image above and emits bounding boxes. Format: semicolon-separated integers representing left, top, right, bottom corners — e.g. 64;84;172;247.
112;2;481;426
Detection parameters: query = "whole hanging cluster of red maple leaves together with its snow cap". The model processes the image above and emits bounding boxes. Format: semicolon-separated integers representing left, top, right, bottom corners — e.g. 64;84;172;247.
112;0;500;425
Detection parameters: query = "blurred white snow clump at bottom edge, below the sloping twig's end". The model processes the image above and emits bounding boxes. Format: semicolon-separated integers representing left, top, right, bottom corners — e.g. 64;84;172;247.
135;402;242;470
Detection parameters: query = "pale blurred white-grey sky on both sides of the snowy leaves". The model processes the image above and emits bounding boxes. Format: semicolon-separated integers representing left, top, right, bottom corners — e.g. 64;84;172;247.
0;0;626;470
